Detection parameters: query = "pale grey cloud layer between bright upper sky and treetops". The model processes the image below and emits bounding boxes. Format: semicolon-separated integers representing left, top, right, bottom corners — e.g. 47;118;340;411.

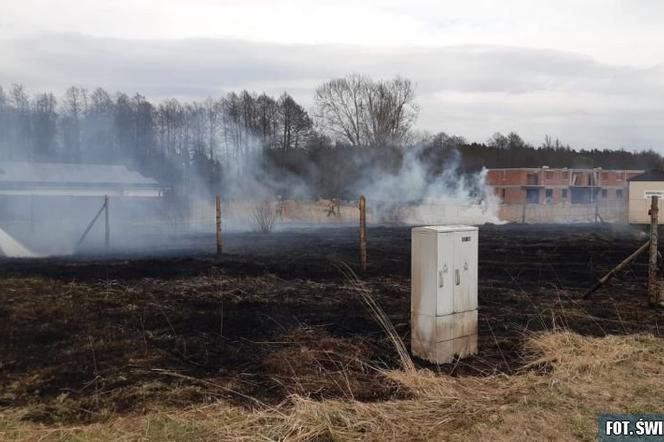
0;34;664;151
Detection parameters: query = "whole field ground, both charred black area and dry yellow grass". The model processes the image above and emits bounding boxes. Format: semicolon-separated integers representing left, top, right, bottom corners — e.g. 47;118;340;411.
0;226;664;440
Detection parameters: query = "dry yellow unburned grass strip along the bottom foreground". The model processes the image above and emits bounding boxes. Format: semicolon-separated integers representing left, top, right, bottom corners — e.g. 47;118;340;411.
0;332;664;441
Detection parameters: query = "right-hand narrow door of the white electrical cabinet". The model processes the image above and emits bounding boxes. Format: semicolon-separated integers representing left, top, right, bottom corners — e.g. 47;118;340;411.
453;231;477;312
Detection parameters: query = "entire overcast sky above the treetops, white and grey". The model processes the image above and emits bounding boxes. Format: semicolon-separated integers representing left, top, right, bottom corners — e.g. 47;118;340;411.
0;0;664;153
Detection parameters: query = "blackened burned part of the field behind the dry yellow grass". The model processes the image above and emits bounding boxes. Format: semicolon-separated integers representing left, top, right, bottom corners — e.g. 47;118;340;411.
0;225;664;422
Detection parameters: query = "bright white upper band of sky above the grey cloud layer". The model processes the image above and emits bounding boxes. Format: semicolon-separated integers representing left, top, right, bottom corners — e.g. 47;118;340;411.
0;0;664;66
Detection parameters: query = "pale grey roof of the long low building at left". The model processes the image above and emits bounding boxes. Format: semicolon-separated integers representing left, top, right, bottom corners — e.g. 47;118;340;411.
0;162;159;186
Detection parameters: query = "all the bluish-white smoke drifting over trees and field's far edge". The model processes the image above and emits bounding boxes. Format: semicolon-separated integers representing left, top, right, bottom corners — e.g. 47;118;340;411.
0;84;498;256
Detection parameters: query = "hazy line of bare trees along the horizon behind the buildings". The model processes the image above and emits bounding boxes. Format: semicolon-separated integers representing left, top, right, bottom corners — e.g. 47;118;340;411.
0;74;664;197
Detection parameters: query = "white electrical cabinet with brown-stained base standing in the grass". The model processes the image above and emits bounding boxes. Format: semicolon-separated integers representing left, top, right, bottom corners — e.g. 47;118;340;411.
411;226;478;364
